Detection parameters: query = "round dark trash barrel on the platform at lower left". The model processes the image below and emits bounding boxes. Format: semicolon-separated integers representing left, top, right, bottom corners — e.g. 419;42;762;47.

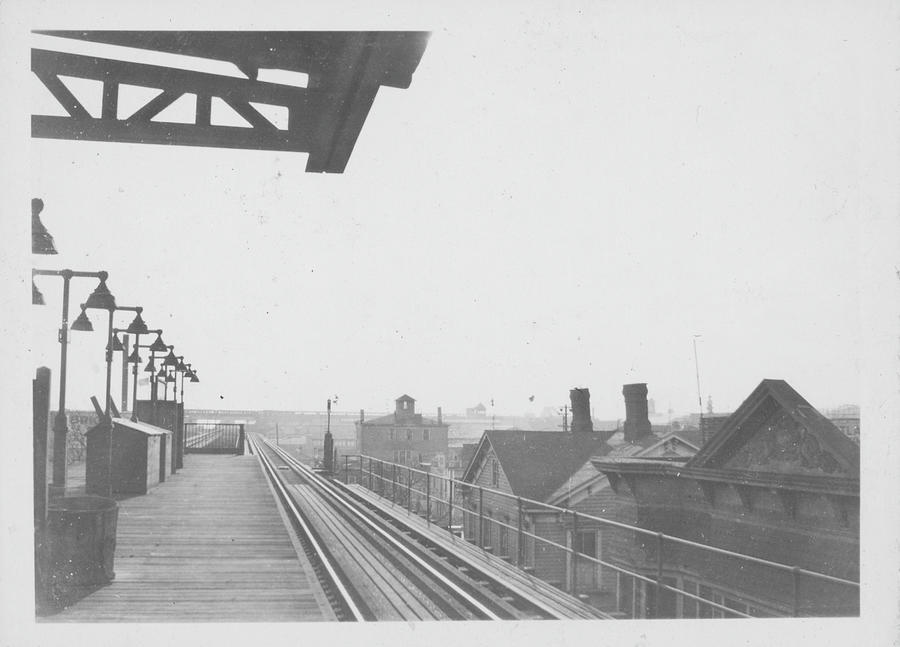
47;496;119;606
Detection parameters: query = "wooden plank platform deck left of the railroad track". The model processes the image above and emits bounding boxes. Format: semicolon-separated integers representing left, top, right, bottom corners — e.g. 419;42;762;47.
39;454;334;622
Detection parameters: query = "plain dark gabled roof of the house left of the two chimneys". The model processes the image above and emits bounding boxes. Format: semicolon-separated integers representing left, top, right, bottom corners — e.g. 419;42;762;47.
462;429;609;501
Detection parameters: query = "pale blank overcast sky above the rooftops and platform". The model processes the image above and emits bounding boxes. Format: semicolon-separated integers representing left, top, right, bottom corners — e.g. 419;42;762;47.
29;2;890;418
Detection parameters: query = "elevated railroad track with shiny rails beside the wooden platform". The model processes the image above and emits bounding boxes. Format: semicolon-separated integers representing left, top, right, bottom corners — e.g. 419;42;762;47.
250;436;592;621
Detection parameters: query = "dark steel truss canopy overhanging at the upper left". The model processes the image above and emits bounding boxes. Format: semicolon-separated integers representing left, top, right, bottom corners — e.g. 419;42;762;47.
31;31;429;173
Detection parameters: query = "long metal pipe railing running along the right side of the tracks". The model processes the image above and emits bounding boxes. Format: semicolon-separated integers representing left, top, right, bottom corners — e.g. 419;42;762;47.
335;455;859;618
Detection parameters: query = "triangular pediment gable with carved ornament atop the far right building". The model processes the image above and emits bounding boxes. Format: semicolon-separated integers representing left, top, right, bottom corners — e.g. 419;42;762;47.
686;379;859;478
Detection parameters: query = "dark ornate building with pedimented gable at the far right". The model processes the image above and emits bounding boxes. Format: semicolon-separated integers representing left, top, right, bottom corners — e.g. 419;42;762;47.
593;380;859;618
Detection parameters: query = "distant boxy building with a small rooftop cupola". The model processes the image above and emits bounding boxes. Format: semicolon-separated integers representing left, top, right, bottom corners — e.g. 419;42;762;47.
356;395;449;468
